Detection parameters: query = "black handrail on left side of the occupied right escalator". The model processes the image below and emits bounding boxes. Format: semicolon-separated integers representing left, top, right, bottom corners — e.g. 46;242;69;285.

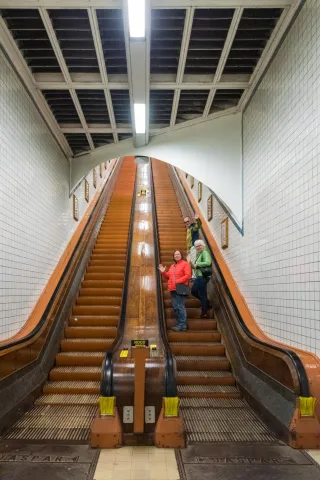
150;159;177;397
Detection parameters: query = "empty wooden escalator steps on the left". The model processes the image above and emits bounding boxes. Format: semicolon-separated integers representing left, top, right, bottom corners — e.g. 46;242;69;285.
0;158;135;441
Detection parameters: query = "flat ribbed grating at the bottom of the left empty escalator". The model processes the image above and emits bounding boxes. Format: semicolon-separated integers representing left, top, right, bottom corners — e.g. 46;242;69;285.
3;405;98;441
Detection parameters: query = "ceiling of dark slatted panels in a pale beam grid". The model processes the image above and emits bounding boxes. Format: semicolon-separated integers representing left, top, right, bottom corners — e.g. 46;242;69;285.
0;0;301;156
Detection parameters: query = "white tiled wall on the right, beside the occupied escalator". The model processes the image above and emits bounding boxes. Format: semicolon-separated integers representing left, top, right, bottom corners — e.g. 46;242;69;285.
182;0;320;355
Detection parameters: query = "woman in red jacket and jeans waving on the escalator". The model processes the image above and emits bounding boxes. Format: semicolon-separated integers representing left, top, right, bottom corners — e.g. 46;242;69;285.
159;250;191;332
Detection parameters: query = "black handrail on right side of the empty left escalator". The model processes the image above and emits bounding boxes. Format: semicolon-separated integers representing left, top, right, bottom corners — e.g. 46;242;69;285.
100;171;137;397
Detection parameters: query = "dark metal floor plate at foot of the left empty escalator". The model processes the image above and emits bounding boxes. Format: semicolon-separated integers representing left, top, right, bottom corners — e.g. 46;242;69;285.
0;441;99;480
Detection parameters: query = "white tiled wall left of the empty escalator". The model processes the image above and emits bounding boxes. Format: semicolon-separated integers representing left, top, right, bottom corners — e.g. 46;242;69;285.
0;51;115;340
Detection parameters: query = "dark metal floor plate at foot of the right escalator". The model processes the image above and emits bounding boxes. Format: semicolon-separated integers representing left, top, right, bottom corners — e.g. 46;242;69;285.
176;443;320;480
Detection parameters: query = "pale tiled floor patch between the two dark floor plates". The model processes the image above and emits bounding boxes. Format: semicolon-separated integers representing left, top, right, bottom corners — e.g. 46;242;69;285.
94;447;180;480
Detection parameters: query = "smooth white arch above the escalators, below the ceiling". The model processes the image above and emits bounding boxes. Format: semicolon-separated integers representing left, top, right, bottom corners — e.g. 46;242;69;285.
71;113;243;225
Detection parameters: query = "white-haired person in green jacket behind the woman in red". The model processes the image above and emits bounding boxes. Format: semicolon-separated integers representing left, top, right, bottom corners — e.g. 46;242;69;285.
188;240;212;318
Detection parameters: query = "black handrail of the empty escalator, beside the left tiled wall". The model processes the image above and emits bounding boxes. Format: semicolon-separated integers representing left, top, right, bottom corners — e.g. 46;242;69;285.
0;163;118;351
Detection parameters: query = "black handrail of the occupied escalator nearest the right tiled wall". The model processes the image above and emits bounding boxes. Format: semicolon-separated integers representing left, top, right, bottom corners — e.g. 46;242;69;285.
172;167;310;397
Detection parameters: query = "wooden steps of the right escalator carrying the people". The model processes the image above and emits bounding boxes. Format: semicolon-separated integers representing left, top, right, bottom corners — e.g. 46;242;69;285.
152;160;275;443
